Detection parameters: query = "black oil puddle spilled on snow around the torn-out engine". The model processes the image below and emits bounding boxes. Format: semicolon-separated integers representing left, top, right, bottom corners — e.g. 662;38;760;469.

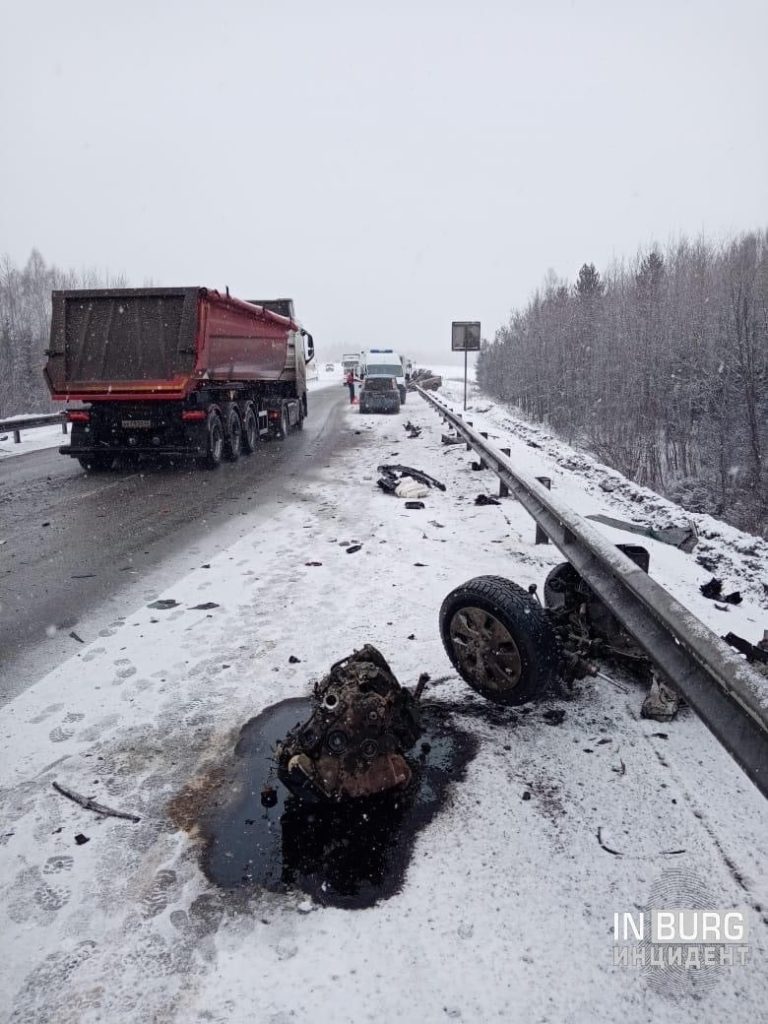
172;697;477;909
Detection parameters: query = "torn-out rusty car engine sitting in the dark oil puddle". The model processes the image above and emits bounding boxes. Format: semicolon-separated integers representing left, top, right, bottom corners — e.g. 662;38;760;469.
276;644;421;801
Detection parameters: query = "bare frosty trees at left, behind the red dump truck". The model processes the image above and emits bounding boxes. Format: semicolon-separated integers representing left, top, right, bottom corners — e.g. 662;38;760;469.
0;250;125;417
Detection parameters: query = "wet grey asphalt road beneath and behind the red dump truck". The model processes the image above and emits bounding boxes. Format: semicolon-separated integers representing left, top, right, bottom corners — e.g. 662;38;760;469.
0;387;356;702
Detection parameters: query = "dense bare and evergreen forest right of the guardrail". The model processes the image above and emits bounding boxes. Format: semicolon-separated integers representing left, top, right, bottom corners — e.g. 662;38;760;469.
477;230;768;534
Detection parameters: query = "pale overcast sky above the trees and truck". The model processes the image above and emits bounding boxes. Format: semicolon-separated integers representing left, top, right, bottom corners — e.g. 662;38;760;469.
0;0;768;361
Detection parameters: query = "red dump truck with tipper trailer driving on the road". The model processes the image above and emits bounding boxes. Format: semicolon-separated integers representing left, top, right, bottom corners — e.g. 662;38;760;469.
45;288;313;470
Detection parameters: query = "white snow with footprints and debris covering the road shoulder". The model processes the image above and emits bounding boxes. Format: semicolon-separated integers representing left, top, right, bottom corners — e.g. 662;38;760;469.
0;385;768;1024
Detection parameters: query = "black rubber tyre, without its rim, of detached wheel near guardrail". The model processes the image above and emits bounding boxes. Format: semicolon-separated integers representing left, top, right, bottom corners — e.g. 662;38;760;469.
439;575;561;705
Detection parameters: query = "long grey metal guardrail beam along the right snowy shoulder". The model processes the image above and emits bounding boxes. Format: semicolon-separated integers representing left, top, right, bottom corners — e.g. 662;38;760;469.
418;388;768;797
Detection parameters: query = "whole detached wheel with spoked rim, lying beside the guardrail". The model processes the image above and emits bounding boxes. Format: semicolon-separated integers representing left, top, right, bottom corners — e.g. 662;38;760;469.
440;577;560;705
